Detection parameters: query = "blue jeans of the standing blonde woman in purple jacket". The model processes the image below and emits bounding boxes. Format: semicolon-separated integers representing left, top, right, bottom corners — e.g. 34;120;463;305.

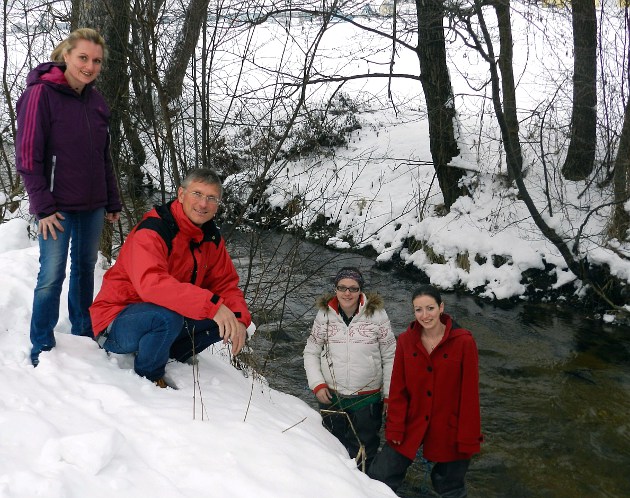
31;208;105;365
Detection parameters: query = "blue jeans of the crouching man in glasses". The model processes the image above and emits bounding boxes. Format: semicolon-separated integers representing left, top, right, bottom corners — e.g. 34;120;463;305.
103;303;221;381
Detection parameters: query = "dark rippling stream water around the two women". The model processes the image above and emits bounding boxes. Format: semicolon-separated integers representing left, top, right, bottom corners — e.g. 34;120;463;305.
229;229;630;498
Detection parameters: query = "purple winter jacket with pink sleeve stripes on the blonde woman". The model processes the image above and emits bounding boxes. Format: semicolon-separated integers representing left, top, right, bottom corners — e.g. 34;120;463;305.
15;62;121;219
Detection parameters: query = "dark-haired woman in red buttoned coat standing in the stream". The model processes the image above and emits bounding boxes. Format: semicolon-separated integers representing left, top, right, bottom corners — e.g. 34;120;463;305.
369;285;483;498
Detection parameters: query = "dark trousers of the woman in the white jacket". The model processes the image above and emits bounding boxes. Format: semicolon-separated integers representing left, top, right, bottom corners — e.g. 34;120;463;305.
319;401;383;470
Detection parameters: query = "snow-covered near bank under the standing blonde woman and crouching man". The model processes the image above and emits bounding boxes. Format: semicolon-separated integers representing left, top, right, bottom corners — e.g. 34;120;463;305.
0;219;395;498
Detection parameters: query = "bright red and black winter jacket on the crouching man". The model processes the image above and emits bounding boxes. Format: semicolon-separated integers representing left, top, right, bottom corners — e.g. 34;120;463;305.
90;199;251;336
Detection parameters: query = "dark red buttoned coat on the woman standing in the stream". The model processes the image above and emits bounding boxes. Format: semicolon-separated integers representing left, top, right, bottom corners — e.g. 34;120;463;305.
385;314;483;462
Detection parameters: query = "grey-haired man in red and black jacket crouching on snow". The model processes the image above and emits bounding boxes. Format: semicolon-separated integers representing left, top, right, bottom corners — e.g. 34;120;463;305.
90;169;251;387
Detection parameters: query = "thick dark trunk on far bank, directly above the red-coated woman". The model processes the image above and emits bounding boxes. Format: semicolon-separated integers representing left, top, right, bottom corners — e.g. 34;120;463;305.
416;0;466;209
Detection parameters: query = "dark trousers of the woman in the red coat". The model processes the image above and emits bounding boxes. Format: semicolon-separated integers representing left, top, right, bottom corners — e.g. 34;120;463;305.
368;444;470;498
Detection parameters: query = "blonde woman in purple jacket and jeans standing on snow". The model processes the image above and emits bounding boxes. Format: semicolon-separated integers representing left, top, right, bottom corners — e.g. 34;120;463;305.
15;28;121;366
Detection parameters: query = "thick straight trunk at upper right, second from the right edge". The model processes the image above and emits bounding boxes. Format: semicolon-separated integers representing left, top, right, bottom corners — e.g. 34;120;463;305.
562;0;597;180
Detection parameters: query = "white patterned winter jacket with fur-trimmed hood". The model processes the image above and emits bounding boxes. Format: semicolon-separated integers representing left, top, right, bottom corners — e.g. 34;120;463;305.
304;293;396;398
